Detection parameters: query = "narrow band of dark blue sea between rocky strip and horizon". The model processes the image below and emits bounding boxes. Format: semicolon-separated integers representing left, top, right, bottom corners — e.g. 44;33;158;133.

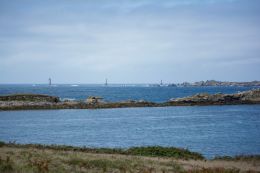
0;84;254;102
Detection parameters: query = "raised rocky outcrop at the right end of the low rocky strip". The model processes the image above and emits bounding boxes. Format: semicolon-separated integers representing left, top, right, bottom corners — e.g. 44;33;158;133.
168;89;260;105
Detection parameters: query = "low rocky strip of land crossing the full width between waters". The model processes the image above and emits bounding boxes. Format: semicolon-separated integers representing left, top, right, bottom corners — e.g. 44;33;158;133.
0;89;260;110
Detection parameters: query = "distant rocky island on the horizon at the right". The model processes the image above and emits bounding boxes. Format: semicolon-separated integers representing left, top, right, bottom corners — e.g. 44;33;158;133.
149;80;260;87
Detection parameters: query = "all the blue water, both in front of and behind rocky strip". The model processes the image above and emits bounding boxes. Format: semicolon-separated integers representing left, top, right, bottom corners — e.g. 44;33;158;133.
0;85;260;158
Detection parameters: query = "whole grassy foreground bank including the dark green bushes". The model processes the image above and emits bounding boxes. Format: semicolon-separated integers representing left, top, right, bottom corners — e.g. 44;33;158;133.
0;142;260;173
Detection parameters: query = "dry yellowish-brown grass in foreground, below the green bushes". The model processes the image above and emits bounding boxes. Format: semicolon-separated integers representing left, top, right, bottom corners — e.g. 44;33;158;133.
0;146;260;173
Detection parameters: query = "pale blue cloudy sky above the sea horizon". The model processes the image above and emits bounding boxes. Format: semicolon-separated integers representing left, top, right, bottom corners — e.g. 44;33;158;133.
0;0;260;83
